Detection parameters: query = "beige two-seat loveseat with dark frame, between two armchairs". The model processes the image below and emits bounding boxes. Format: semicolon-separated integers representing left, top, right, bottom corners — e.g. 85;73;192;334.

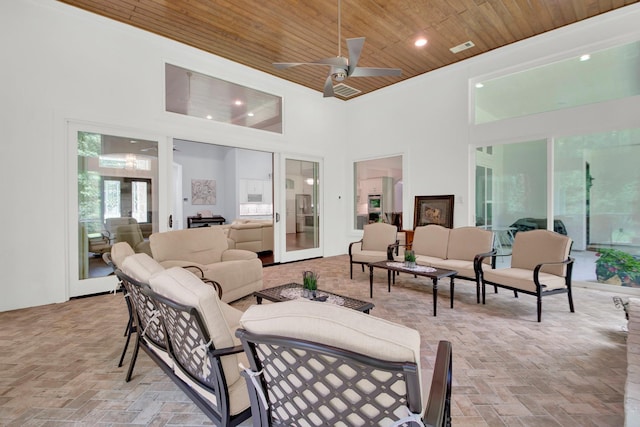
402;224;495;303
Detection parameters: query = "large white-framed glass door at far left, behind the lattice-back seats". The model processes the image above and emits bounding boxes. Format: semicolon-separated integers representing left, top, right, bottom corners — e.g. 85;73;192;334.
68;125;166;297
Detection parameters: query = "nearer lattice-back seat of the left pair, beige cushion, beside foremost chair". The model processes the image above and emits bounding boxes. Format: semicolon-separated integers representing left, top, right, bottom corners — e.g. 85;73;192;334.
143;267;251;426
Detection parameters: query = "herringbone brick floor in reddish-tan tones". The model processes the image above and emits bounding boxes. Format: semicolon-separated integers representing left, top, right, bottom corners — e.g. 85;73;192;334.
0;256;626;426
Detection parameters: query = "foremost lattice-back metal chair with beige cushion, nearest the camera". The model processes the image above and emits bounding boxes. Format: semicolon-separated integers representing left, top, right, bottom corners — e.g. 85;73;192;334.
236;301;452;427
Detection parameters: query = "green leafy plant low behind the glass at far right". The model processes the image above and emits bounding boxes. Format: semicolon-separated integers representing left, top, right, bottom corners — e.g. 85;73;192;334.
596;248;640;287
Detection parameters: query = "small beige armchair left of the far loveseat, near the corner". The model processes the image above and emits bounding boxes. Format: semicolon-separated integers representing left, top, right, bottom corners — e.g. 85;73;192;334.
349;222;398;279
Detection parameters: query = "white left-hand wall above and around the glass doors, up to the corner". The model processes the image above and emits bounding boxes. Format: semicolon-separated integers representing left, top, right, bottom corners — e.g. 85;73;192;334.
0;0;345;311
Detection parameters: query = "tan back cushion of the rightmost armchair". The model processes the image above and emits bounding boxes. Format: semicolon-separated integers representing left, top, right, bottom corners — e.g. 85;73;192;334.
511;230;572;277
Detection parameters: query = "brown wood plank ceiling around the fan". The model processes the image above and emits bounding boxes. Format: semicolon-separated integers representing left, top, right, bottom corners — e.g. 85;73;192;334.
60;0;640;99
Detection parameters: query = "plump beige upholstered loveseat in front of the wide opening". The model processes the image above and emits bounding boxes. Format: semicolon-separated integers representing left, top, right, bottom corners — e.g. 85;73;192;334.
149;227;262;302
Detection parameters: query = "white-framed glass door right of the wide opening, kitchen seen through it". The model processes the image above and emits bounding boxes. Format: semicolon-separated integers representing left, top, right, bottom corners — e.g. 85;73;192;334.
279;155;322;262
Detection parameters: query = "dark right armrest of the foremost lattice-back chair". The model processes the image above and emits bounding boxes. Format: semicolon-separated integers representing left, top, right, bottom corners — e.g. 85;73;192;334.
422;341;452;426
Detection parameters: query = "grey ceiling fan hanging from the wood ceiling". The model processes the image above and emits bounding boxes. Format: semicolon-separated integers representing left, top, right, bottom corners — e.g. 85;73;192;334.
273;0;402;98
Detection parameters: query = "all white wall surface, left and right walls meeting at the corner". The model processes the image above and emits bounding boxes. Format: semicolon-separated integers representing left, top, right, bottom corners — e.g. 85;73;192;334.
0;0;640;311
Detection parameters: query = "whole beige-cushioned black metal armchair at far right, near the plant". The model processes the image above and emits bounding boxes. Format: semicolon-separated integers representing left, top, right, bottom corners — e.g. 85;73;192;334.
476;230;574;322
